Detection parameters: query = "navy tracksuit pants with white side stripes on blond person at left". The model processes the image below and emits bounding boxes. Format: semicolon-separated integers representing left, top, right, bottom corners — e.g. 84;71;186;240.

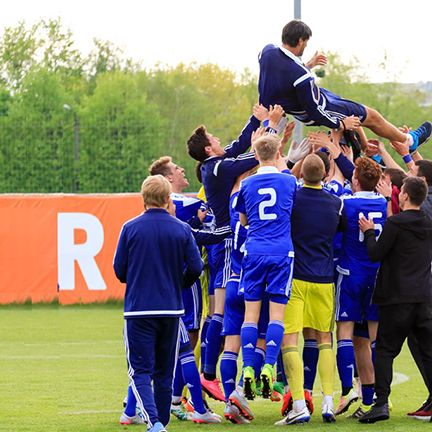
124;317;179;427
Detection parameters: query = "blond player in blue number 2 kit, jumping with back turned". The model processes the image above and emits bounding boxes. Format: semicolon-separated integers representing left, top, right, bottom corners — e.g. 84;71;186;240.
236;135;297;399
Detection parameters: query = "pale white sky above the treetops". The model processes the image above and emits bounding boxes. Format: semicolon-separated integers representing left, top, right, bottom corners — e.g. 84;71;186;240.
0;0;432;82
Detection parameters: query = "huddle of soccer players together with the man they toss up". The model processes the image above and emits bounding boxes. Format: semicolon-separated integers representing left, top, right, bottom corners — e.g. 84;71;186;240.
117;17;432;425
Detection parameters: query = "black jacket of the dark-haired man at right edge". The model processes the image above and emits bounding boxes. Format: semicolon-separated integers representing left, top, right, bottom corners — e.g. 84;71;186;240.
365;210;432;305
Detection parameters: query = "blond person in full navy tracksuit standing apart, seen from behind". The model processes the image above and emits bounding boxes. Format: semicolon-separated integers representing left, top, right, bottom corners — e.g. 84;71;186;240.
114;176;203;432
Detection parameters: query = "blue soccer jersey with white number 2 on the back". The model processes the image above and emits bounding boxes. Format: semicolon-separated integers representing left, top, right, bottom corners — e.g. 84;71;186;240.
235;167;297;256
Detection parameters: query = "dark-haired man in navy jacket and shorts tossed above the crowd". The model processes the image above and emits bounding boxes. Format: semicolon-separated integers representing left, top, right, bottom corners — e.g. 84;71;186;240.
258;20;432;152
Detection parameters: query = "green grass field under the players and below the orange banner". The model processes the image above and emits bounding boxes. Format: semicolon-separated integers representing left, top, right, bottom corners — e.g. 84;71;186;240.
0;305;432;432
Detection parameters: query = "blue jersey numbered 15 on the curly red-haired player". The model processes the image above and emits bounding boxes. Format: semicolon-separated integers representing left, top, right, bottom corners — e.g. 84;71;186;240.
338;192;387;271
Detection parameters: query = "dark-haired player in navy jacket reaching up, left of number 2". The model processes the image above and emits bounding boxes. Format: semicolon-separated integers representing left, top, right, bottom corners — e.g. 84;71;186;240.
188;106;268;394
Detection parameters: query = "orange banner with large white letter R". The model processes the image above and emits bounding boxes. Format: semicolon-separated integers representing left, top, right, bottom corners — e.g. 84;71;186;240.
0;194;143;304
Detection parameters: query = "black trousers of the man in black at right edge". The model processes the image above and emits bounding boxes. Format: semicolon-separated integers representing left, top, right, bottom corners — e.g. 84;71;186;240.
375;303;432;406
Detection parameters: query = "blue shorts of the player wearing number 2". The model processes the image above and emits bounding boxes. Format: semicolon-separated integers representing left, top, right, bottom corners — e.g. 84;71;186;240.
241;252;294;304
